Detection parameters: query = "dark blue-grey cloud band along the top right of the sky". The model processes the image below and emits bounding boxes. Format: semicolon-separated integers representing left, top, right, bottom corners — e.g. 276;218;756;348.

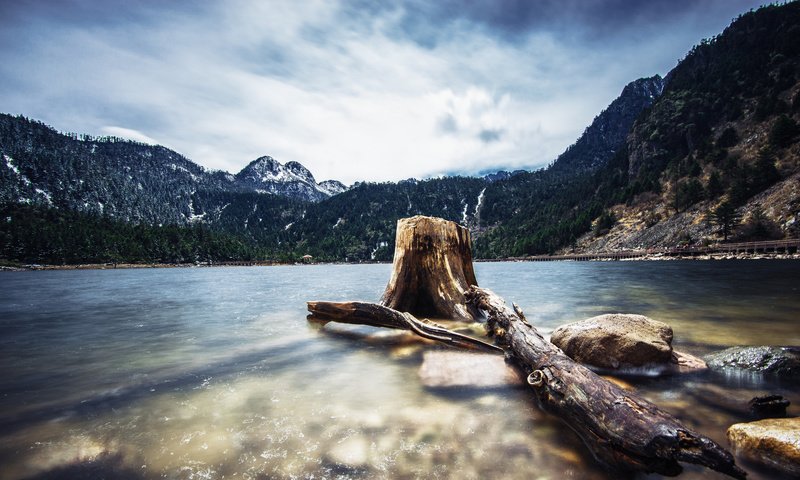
343;0;757;48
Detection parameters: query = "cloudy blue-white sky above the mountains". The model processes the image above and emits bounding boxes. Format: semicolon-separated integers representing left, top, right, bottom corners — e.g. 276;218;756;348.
0;0;761;184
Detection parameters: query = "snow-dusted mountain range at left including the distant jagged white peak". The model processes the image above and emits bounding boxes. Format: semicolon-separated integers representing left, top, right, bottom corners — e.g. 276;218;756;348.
0;115;346;225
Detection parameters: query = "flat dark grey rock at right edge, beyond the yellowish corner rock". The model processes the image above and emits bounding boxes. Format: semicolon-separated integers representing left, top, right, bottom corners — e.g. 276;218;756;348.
705;346;800;378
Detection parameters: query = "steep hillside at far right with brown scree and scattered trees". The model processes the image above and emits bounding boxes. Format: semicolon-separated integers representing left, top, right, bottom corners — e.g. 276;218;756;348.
578;3;800;251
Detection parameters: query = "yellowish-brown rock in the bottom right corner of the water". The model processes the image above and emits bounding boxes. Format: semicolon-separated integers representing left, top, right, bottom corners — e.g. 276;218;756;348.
728;418;800;478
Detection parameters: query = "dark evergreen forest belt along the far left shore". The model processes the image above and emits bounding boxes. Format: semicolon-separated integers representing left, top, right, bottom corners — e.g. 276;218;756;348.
0;204;294;265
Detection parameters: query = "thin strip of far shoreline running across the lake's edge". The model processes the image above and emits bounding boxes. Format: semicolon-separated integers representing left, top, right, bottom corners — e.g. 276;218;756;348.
0;253;800;272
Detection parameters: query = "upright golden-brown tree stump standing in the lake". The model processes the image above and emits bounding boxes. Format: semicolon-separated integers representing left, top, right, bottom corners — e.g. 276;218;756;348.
380;215;482;321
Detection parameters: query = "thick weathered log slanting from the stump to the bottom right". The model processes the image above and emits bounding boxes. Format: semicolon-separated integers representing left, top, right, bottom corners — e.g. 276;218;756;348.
468;287;747;478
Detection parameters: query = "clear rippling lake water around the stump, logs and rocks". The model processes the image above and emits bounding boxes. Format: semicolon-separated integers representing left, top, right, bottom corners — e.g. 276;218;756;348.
0;261;800;479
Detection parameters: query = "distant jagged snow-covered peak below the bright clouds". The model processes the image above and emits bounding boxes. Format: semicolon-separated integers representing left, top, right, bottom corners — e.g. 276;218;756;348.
235;157;347;202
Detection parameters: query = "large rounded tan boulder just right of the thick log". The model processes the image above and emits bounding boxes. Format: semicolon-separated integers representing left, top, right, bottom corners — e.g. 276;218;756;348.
550;313;672;369
